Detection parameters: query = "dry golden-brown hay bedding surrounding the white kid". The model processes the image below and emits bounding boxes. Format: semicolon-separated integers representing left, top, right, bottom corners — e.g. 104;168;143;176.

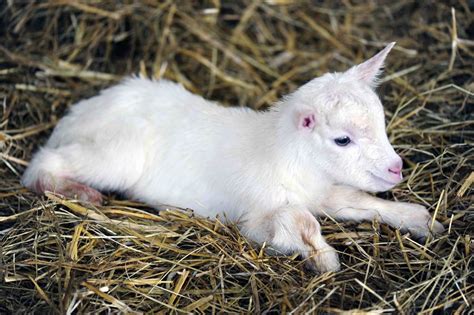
0;0;474;314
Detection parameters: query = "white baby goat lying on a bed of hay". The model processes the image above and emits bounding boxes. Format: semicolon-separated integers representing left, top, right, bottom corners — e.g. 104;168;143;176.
22;43;443;272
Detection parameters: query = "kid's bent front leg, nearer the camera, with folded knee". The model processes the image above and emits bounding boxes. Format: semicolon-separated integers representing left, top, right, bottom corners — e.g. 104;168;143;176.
242;207;340;273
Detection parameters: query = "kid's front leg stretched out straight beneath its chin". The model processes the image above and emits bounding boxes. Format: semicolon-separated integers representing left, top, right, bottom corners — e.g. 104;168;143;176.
323;185;444;239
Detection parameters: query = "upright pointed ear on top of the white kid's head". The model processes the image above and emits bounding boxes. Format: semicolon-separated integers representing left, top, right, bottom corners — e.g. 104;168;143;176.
347;42;395;87
